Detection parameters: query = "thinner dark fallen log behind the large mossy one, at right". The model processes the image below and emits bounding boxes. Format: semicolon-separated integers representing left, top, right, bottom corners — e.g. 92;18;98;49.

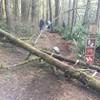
42;50;100;72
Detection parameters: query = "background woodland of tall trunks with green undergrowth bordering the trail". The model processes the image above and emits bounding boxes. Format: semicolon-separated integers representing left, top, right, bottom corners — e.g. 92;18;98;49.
0;0;100;58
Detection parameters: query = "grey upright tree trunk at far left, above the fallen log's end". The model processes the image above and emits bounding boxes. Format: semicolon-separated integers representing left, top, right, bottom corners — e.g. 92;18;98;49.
5;0;11;29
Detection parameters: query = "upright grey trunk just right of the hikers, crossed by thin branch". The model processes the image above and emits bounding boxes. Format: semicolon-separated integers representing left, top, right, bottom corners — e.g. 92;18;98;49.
55;0;60;25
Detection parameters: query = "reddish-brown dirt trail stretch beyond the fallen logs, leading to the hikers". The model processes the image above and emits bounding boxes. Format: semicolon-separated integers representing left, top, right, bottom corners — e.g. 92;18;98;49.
36;33;75;58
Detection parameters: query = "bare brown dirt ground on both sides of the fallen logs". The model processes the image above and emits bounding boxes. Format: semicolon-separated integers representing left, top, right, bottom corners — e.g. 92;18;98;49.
0;33;100;100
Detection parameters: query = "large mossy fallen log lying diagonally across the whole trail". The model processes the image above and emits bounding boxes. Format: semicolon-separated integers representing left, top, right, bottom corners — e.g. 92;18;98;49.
0;29;100;92
